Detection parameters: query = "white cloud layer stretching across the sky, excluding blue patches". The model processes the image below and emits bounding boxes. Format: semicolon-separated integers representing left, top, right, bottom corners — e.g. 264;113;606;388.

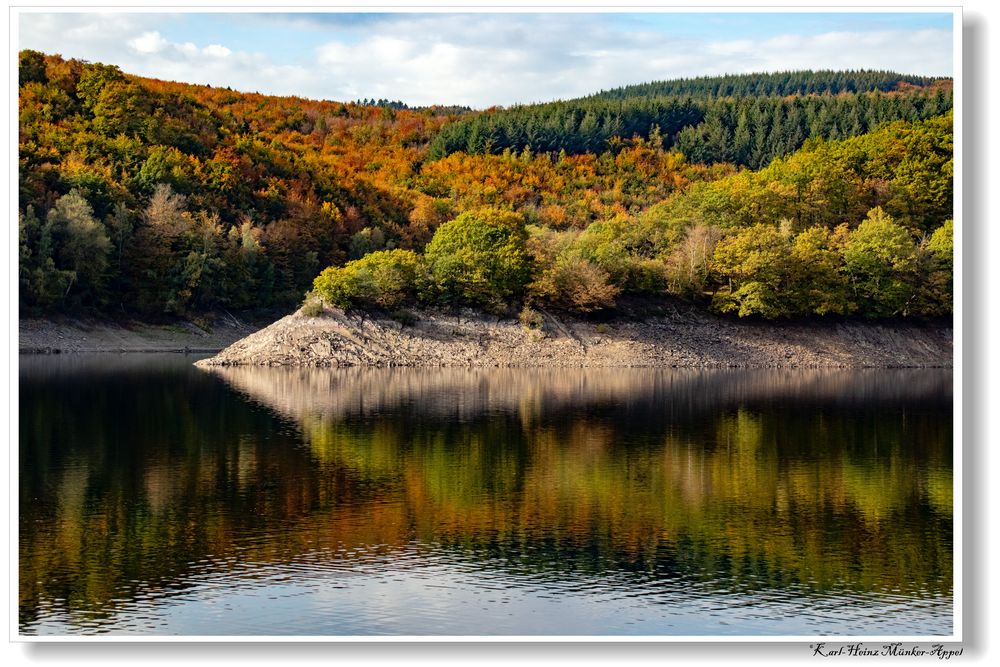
20;13;952;107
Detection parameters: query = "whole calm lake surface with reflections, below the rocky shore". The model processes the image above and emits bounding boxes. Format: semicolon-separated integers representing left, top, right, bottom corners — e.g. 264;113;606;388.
19;355;953;635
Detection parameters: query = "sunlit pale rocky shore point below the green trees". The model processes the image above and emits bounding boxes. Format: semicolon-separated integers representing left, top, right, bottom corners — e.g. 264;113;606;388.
198;309;952;368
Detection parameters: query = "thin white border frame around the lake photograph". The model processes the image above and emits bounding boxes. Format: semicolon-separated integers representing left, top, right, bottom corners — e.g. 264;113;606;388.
7;0;960;649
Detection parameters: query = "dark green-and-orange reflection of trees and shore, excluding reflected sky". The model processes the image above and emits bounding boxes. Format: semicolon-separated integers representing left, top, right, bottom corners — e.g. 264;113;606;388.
19;357;953;631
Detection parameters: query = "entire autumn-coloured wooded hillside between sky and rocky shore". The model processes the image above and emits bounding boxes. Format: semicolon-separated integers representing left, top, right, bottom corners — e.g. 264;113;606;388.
18;51;952;320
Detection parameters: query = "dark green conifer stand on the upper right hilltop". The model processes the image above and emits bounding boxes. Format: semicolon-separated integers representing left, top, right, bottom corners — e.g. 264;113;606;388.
430;72;952;169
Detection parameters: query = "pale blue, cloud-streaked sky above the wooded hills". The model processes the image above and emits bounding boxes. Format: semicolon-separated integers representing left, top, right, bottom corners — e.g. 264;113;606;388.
17;10;952;108
